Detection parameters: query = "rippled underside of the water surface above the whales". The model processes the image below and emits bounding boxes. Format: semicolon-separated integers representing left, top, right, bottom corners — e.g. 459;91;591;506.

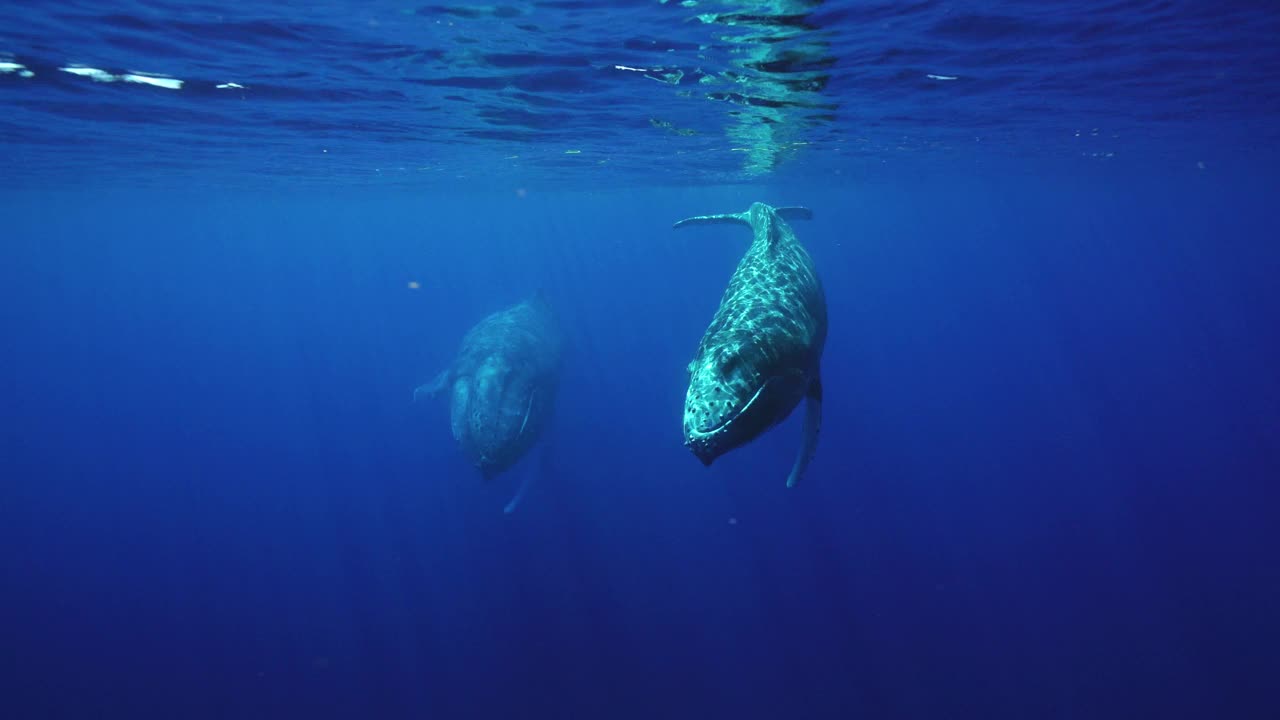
0;0;1280;184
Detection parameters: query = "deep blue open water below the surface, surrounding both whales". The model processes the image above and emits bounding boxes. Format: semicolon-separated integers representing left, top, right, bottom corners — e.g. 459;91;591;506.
3;176;1280;717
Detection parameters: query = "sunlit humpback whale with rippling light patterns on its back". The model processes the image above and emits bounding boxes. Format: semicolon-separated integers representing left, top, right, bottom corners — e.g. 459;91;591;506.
673;202;827;487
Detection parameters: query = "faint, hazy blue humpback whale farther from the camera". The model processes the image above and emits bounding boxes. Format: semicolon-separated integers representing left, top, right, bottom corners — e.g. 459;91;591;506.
413;291;563;512
